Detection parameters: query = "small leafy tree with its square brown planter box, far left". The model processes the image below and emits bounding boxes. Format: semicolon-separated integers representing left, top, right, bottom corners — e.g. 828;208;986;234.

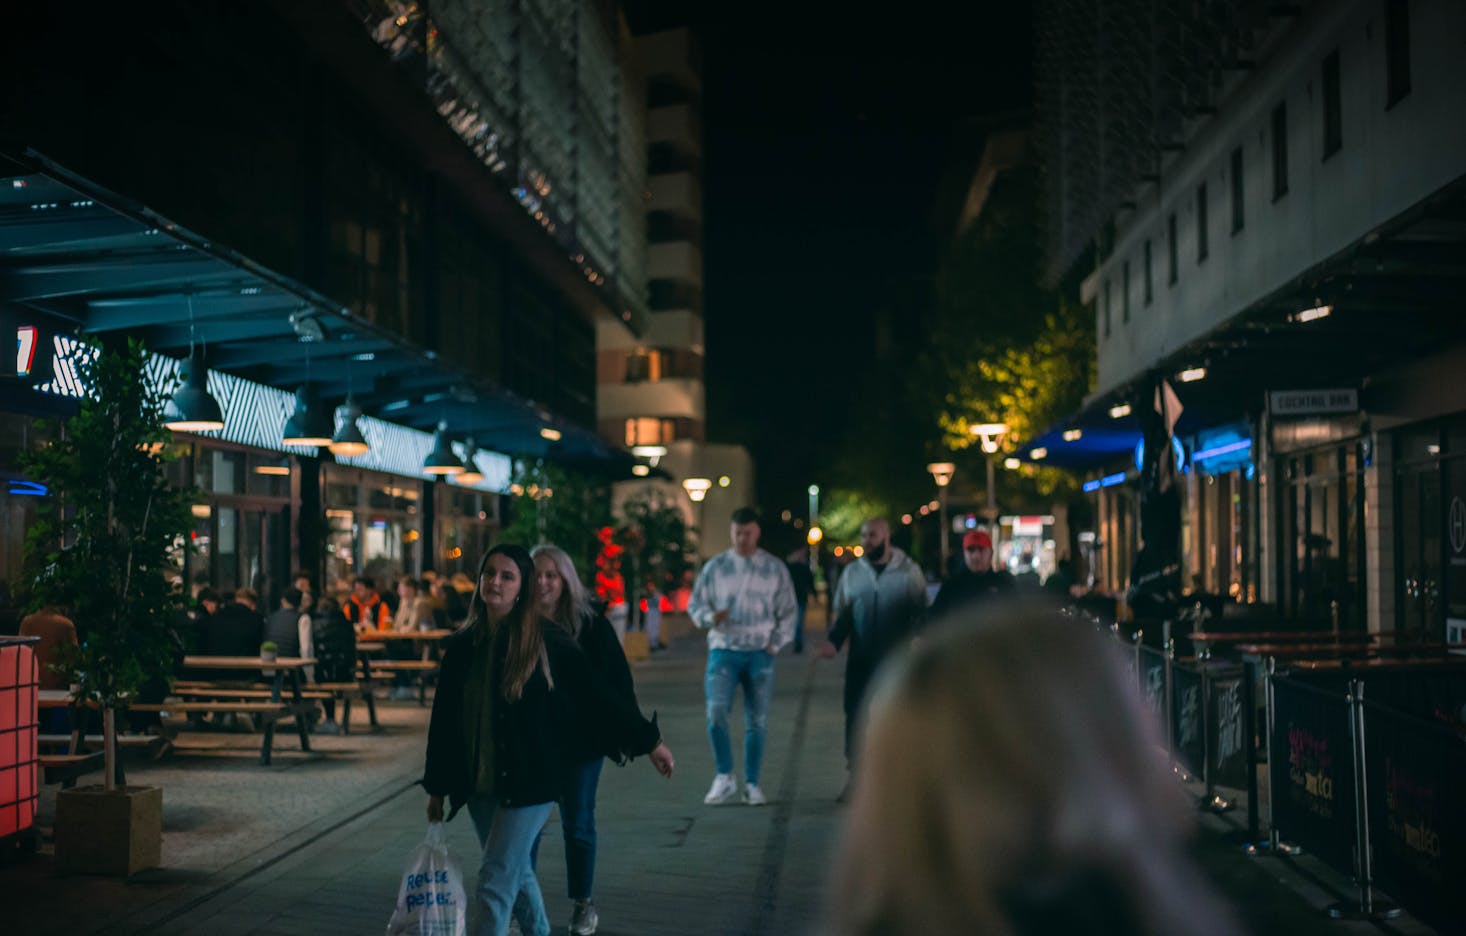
21;340;191;874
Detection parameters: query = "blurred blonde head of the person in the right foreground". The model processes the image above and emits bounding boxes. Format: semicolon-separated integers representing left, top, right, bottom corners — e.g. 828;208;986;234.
830;603;1236;936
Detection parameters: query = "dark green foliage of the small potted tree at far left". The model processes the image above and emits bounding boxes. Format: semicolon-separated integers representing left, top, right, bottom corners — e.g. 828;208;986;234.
21;340;191;709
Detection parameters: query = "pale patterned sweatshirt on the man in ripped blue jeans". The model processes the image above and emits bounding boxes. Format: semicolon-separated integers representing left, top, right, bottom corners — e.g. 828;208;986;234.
688;549;796;653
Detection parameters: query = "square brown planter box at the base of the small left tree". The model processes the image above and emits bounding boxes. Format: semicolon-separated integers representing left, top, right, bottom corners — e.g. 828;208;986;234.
56;786;163;876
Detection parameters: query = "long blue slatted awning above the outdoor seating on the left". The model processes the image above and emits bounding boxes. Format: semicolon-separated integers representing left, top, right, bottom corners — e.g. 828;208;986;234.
0;151;636;477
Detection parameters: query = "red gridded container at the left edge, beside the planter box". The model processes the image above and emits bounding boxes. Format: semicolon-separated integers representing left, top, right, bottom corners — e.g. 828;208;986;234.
0;637;41;844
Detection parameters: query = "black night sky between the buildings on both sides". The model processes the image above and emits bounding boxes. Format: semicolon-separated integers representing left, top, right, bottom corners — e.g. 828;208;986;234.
633;3;1034;509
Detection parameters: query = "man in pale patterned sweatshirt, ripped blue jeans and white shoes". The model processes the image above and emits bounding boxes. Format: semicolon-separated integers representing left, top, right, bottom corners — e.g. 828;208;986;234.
688;508;796;805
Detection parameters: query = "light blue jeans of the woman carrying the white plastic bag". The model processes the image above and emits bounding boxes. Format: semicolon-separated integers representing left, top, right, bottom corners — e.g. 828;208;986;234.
468;795;554;936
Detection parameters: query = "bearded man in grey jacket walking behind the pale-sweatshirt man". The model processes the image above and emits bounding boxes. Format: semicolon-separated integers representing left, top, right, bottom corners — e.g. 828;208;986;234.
819;516;927;802
